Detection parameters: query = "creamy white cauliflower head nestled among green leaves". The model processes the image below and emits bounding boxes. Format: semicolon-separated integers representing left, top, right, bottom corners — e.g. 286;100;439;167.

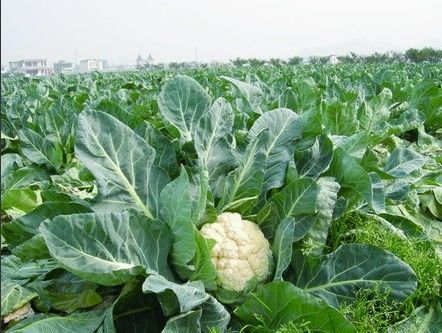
201;213;272;292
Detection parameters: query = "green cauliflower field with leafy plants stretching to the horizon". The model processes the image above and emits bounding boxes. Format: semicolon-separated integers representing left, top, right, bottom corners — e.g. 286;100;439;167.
1;64;442;333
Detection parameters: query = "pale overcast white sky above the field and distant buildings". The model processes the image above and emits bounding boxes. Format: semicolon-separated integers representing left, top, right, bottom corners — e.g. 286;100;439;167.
1;0;442;64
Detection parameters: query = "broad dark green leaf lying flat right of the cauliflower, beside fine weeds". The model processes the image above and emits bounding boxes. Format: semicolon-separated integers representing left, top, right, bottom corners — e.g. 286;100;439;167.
302;244;417;306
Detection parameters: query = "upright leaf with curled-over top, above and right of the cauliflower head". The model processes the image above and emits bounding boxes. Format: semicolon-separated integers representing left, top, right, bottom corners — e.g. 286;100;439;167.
248;109;302;191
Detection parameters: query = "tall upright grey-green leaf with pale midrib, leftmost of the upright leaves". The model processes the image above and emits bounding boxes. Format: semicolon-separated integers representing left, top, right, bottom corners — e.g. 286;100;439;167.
75;111;168;217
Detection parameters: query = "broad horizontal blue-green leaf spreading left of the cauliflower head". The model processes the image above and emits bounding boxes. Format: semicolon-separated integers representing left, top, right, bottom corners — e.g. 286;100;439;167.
40;211;171;286
